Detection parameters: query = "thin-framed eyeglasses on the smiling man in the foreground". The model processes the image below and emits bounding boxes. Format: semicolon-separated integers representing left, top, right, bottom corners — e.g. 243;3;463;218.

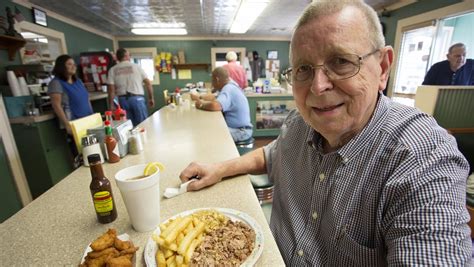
283;49;380;85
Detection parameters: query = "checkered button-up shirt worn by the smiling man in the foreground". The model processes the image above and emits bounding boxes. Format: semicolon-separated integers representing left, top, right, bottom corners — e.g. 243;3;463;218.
264;95;472;266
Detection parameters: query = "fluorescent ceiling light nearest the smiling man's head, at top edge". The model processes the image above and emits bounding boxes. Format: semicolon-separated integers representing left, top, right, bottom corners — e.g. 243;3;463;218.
230;0;270;33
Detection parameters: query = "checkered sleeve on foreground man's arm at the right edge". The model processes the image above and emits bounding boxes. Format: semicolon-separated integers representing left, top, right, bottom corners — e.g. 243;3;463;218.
382;145;472;266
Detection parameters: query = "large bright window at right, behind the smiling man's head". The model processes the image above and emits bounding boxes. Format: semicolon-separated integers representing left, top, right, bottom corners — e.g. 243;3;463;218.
387;0;474;99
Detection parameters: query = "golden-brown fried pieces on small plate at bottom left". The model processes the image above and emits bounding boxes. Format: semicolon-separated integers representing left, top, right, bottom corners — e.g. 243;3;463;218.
80;229;138;267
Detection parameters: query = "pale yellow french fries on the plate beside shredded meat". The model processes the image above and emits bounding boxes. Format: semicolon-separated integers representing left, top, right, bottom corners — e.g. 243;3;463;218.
152;210;228;267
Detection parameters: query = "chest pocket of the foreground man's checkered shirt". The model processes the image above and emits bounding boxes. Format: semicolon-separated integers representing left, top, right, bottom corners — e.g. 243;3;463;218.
337;225;385;266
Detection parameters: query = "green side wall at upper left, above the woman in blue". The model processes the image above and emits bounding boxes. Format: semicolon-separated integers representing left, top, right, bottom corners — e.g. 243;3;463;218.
0;1;113;85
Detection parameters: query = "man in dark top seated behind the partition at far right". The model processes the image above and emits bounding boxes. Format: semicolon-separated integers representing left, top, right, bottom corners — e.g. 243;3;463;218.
423;43;474;85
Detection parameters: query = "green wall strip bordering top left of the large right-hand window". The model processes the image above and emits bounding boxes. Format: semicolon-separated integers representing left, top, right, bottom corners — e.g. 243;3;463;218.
380;0;462;46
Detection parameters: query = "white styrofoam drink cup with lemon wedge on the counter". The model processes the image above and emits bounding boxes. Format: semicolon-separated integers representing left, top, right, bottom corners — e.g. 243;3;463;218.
115;164;160;232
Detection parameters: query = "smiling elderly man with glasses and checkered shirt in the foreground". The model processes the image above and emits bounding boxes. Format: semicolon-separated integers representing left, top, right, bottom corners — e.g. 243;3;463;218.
180;1;472;266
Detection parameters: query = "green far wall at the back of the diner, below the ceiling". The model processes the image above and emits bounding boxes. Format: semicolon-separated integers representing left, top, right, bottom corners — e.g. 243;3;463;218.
118;38;290;110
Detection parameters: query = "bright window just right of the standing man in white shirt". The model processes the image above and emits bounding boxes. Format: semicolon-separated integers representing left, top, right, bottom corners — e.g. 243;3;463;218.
126;47;160;85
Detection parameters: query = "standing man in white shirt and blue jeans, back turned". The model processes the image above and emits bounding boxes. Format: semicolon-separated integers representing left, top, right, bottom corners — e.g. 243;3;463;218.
108;48;155;126
